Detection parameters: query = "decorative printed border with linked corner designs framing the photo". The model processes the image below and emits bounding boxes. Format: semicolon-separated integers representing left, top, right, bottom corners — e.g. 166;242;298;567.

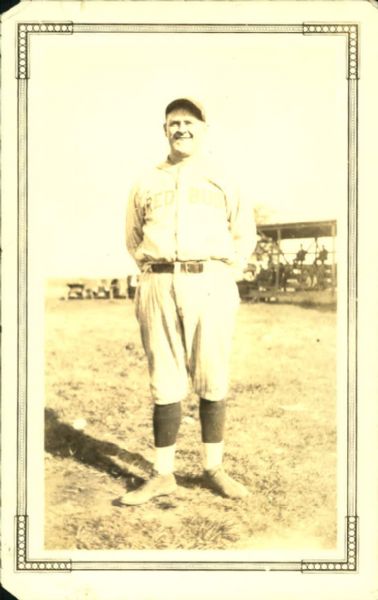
15;22;359;573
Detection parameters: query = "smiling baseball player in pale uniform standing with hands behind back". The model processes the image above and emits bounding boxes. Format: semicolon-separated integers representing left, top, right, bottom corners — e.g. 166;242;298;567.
120;98;256;505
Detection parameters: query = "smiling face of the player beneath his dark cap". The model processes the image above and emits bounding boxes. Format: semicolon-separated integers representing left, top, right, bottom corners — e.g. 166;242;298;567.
164;108;206;158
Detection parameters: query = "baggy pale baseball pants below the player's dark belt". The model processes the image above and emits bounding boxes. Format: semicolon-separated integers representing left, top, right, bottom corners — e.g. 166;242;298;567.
135;261;239;405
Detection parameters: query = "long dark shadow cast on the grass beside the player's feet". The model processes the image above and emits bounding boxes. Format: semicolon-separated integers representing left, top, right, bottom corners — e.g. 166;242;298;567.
45;408;152;489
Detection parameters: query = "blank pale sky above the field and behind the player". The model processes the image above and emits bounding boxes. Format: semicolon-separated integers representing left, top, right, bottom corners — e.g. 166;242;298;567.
28;33;347;277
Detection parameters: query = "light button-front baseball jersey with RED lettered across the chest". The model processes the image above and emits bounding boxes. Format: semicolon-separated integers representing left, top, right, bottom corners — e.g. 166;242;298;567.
126;158;257;273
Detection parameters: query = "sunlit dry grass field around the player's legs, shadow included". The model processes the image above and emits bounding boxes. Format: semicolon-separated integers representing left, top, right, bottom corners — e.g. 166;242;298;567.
45;297;337;550
